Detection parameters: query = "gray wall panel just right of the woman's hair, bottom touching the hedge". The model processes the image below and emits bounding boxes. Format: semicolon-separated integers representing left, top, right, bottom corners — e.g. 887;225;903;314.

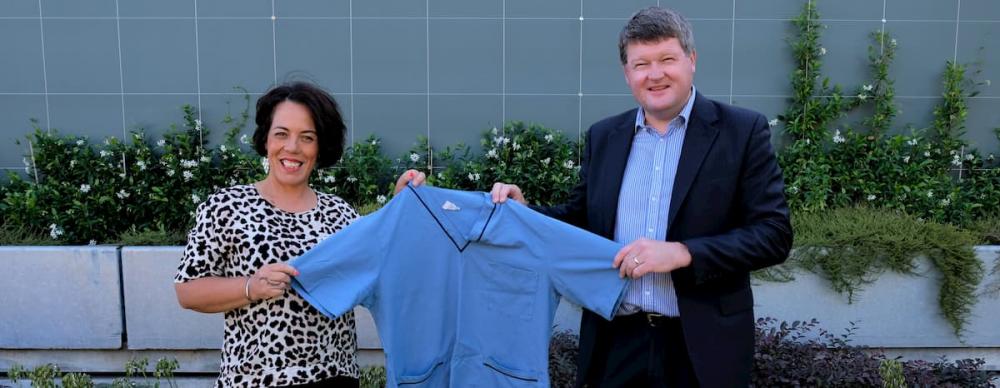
353;95;426;159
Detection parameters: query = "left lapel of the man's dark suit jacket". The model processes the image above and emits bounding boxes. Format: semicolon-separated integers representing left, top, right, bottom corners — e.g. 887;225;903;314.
600;109;638;238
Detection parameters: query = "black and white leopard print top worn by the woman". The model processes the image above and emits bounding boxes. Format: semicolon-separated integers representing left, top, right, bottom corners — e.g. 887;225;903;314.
174;185;358;387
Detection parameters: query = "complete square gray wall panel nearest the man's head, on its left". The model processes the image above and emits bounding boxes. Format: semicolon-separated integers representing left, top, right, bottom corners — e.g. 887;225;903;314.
505;20;580;94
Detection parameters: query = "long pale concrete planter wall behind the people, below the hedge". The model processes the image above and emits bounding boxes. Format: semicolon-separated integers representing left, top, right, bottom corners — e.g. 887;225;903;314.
0;246;1000;372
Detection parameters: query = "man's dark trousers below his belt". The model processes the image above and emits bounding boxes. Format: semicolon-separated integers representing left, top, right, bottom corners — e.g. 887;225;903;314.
594;313;698;388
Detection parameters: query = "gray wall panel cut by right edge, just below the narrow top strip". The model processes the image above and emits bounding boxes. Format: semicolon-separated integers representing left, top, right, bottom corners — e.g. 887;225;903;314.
958;21;1000;97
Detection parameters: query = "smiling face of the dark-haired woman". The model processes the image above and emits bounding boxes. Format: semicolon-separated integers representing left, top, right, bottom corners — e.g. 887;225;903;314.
265;101;319;186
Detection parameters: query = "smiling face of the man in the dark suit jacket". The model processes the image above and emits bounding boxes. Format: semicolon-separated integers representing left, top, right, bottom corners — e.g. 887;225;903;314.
625;38;698;120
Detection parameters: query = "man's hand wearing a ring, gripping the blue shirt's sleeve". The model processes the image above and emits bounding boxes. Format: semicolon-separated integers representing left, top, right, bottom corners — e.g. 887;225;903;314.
612;238;691;279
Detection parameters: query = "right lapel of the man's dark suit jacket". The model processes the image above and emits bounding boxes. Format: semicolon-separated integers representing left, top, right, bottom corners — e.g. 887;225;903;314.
668;93;719;235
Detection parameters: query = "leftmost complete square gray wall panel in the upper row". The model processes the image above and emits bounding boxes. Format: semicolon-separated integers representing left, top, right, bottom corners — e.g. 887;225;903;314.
45;19;121;93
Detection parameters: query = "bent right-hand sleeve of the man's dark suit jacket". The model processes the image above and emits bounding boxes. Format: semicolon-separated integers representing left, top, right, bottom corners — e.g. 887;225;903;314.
681;114;792;283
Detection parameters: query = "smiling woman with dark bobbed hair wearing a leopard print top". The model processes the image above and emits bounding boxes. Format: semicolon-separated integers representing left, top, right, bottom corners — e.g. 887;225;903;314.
174;83;424;387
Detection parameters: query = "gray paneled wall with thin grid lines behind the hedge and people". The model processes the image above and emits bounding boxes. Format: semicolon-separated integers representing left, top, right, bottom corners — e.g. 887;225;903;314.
0;0;1000;171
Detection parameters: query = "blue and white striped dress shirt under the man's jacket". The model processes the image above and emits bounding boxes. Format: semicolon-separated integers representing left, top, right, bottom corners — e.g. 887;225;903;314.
615;86;695;317
